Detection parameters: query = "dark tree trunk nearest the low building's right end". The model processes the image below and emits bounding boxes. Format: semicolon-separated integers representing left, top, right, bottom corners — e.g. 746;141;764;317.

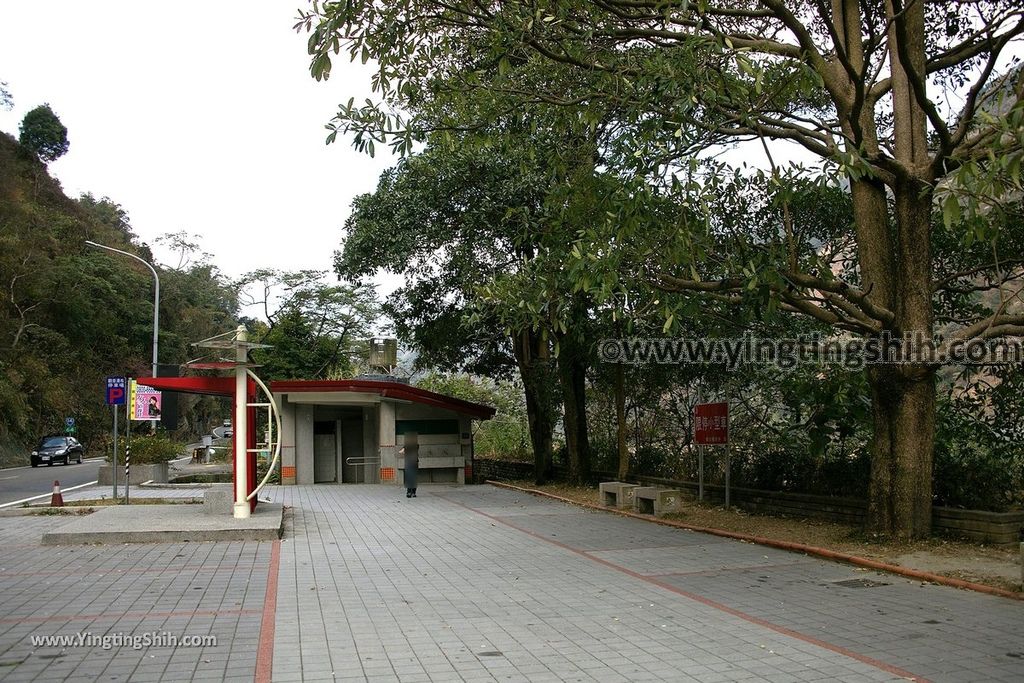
512;331;555;485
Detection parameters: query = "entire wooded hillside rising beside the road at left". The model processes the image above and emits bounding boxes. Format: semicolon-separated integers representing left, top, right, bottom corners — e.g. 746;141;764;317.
0;133;238;465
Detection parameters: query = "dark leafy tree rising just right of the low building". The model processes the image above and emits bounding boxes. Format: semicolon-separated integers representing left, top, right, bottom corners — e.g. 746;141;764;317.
335;144;557;482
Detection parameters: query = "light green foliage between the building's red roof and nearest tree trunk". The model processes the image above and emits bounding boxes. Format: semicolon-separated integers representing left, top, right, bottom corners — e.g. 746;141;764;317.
416;372;531;461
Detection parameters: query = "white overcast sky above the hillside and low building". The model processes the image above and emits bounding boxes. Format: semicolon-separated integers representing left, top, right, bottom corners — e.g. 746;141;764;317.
0;0;394;276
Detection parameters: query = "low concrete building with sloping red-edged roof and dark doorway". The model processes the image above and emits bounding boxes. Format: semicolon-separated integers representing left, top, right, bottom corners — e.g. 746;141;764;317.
270;378;495;486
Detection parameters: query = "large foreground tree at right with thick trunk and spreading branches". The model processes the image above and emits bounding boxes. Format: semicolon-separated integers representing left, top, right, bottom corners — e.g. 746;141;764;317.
300;0;1024;537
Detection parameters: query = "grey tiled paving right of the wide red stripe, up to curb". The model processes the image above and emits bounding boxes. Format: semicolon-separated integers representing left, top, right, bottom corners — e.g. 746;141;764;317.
273;486;1024;682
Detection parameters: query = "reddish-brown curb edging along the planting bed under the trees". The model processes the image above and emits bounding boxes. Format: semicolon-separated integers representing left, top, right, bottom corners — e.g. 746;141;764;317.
485;481;1024;600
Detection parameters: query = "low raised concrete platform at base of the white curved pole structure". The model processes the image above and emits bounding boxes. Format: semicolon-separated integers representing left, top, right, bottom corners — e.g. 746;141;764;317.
43;503;285;546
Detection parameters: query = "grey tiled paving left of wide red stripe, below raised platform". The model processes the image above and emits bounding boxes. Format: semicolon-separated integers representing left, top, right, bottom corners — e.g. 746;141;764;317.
0;516;272;683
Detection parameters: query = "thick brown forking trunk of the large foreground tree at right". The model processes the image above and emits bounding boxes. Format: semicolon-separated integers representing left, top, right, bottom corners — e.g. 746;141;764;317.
840;0;936;539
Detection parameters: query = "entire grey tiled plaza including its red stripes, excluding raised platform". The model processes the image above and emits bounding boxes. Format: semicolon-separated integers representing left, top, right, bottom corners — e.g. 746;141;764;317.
0;485;1024;682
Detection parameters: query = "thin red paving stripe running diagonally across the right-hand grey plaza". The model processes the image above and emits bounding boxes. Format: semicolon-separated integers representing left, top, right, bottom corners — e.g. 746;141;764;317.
434;489;928;683
